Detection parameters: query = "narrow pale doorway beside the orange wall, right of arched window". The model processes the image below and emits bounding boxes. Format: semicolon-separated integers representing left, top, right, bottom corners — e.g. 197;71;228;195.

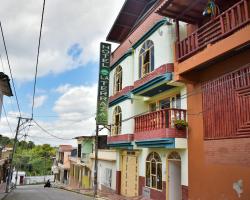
168;160;182;200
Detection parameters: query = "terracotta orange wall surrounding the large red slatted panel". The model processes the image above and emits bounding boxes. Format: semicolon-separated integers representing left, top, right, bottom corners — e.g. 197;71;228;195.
185;50;250;200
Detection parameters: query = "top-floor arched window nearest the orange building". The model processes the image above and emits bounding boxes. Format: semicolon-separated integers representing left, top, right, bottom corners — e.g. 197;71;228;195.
139;40;154;78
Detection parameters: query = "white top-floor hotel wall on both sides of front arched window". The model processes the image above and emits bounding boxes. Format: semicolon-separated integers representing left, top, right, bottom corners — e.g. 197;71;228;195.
134;25;175;81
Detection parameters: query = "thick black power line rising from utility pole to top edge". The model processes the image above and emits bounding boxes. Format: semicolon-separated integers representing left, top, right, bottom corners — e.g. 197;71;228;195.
31;0;45;118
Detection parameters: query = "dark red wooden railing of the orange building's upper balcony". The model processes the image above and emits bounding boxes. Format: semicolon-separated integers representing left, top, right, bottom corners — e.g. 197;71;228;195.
176;0;250;61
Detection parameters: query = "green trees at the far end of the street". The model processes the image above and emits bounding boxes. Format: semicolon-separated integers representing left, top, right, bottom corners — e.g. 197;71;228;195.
0;136;56;176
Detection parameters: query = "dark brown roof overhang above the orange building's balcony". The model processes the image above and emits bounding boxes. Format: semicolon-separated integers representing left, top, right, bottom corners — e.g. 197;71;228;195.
156;0;207;24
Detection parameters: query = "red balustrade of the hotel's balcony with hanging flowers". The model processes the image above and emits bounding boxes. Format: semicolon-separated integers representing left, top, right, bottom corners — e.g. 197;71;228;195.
135;108;186;133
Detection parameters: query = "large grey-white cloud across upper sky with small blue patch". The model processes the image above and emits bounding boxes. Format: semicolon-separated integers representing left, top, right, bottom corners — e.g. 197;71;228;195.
0;0;124;81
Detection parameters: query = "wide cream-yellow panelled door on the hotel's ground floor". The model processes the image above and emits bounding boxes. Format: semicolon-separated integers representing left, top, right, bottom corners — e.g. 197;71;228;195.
121;152;138;197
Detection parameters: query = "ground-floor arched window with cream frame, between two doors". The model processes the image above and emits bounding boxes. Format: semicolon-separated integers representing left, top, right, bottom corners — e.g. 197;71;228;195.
146;152;162;190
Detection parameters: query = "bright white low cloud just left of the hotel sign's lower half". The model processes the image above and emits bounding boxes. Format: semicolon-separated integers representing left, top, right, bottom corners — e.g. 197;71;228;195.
0;84;107;145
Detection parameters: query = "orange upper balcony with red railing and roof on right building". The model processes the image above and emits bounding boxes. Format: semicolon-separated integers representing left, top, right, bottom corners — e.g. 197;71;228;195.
157;0;250;74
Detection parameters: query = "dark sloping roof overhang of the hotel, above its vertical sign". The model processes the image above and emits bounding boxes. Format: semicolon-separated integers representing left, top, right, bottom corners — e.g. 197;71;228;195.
106;0;157;43
